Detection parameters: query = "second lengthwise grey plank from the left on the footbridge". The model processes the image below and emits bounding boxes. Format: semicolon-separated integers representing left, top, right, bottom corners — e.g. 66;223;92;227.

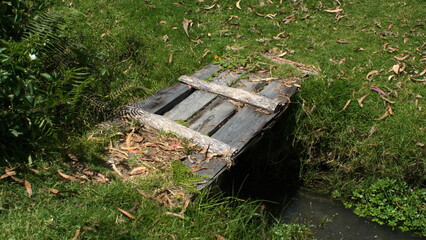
164;71;244;120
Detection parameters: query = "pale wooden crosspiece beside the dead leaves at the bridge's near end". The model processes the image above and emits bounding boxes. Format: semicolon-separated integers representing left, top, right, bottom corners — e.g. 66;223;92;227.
124;106;236;158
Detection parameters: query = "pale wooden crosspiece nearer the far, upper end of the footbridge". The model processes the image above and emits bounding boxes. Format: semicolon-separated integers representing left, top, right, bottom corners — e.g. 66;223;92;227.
179;76;281;113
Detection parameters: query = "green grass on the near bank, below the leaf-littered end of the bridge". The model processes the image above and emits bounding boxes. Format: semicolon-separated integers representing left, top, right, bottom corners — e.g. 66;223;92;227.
0;164;310;239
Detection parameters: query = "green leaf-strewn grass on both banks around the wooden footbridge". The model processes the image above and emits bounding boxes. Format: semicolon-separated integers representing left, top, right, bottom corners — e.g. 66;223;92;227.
1;0;426;239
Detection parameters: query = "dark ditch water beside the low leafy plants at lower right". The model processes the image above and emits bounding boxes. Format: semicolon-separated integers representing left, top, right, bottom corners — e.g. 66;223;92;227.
276;190;422;240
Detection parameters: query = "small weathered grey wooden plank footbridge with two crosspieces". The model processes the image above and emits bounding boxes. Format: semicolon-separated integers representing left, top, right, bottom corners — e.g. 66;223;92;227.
125;58;301;189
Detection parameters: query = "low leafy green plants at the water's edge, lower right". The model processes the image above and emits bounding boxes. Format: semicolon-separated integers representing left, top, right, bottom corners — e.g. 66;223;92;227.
334;178;426;236
